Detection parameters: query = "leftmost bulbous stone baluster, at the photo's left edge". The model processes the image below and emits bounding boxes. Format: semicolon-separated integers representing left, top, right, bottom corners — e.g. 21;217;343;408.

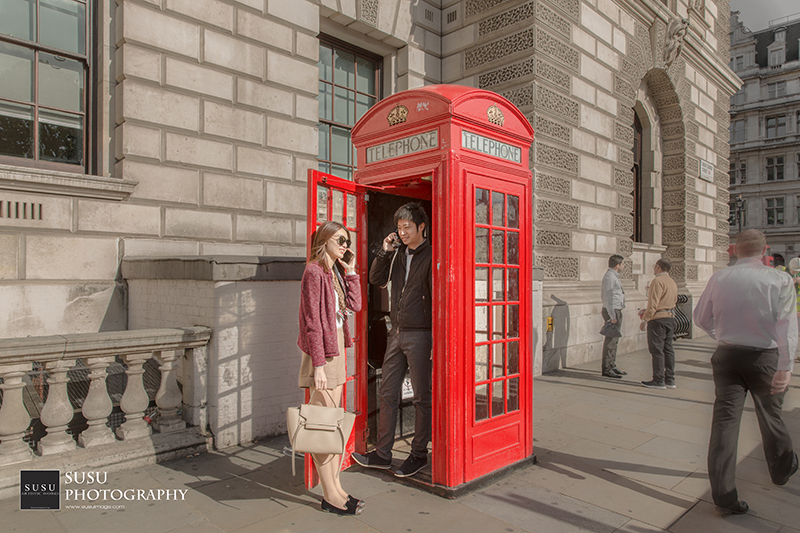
0;363;33;464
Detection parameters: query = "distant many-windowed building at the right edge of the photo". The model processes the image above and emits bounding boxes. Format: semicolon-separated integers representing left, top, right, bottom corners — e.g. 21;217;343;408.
730;12;800;263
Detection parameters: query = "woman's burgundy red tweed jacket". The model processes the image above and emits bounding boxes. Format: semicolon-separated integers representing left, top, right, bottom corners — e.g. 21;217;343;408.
297;263;361;367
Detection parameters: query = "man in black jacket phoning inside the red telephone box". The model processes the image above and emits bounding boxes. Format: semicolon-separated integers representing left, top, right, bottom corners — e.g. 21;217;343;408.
353;202;433;477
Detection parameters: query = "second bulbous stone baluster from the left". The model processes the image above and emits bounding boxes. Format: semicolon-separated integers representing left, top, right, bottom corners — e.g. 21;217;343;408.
38;360;75;455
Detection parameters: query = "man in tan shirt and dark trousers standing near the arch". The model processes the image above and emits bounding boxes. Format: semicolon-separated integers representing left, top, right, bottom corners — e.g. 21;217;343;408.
639;257;678;389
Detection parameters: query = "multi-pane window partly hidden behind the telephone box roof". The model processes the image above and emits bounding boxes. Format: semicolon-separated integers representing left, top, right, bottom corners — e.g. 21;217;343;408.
317;36;381;180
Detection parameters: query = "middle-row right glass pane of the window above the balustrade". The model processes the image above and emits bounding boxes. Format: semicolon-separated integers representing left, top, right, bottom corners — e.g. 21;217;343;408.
39;52;83;111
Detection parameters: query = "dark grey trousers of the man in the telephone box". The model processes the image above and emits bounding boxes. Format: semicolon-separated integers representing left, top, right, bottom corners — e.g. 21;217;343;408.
376;328;433;459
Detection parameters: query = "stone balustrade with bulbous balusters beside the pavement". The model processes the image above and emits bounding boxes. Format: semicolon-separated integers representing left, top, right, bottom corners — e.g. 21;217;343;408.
0;326;211;468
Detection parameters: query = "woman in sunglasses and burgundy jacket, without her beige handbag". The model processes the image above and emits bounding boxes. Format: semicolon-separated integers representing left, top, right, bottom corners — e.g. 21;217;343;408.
297;222;364;515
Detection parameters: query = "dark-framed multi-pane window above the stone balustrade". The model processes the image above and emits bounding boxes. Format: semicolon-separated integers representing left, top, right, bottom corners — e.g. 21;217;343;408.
0;0;91;171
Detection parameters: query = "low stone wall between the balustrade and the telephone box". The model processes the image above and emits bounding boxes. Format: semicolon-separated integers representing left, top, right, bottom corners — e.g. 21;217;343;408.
124;260;303;448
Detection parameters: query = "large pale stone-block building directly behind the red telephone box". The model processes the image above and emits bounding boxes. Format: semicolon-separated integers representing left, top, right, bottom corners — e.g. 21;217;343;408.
0;0;739;443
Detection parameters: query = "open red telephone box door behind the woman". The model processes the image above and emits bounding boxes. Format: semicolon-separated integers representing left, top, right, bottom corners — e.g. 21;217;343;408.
305;169;369;489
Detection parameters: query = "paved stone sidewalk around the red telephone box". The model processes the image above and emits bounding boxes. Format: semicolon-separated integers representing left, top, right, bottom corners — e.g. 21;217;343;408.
0;339;800;533
